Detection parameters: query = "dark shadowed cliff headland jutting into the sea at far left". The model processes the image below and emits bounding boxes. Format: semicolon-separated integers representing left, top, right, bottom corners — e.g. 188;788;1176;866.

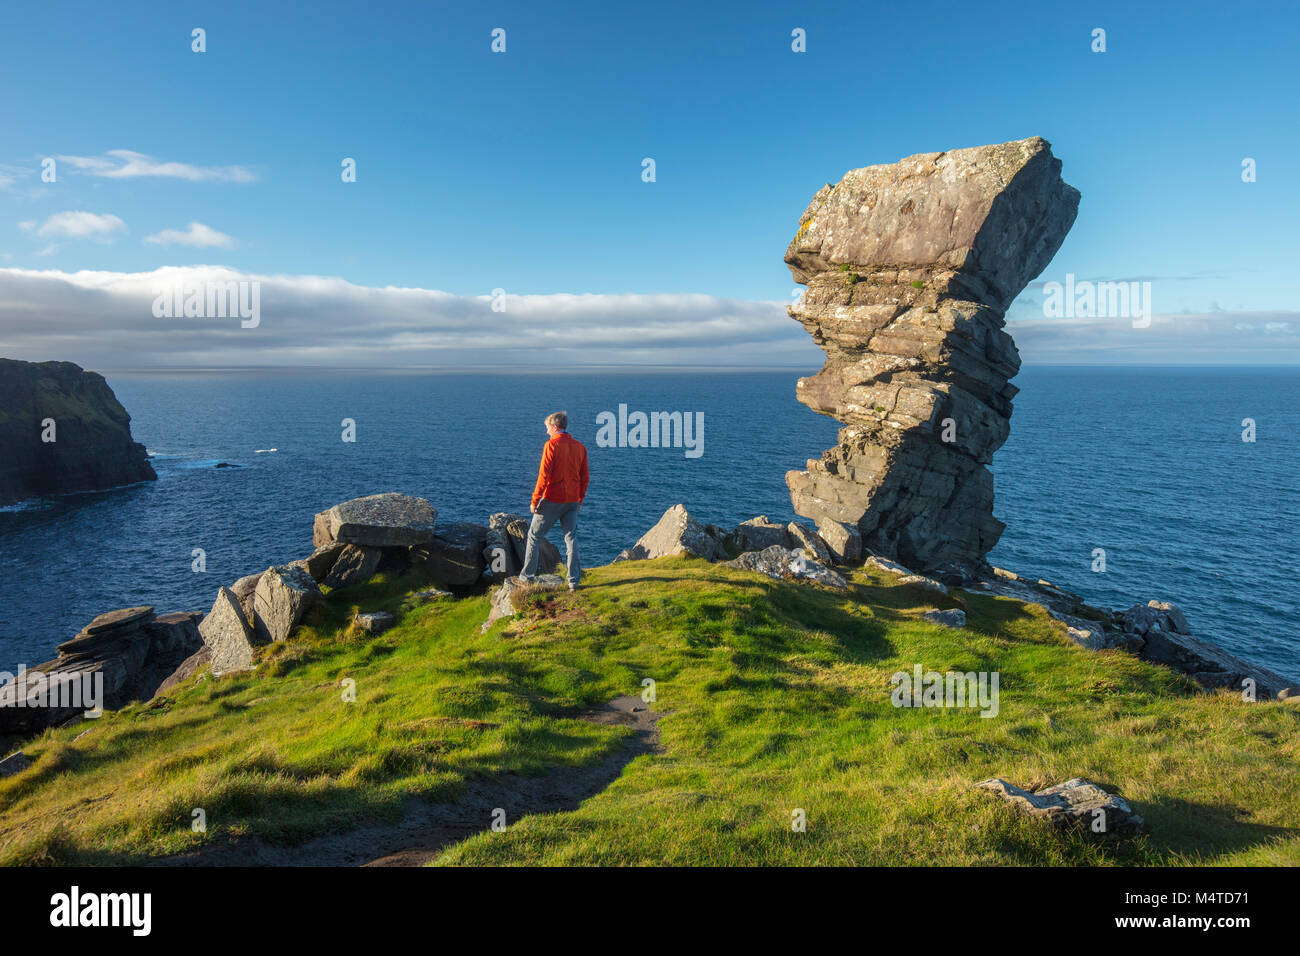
0;359;157;505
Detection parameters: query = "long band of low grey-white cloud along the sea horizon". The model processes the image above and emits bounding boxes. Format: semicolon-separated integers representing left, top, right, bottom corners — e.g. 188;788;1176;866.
0;273;1300;368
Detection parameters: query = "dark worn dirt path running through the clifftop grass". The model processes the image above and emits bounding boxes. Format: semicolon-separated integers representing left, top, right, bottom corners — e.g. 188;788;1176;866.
151;697;660;866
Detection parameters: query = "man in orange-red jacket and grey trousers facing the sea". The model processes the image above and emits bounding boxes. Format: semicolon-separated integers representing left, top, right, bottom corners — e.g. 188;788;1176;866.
519;411;588;591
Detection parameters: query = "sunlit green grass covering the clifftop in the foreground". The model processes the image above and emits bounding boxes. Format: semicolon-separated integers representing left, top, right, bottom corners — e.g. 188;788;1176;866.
0;559;1300;865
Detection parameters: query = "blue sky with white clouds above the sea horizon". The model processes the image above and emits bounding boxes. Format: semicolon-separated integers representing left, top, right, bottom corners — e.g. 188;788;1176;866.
0;0;1300;368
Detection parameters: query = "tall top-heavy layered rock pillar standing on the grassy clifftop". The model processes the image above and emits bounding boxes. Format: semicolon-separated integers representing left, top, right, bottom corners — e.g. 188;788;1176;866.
785;137;1079;579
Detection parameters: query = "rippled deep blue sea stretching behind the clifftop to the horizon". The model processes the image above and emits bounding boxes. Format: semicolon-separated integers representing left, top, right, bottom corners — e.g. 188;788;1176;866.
0;367;1300;676
